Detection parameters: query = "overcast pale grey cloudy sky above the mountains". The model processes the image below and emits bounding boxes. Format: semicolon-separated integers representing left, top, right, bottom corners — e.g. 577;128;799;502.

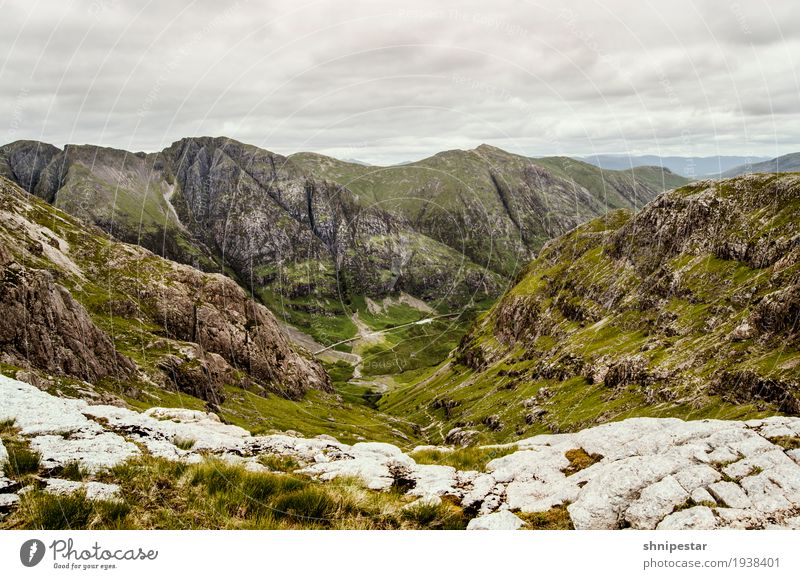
0;0;800;163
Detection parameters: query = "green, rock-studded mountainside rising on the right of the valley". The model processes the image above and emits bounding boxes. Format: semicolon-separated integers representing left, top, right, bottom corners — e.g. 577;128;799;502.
379;175;800;441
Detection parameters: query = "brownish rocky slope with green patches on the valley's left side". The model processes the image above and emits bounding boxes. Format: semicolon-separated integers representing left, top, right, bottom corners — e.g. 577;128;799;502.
0;178;331;407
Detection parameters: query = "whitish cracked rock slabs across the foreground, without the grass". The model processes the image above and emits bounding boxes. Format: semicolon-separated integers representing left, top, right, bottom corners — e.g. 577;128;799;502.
0;376;800;529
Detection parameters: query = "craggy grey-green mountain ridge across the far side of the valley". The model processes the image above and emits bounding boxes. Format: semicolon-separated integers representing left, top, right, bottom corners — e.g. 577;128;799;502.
0;137;684;343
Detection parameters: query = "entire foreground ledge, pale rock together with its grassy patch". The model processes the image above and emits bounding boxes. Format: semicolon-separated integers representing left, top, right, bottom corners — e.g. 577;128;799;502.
0;376;800;529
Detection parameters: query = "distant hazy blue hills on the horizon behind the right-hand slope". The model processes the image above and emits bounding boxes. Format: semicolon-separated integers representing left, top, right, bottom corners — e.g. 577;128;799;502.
576;155;769;179
